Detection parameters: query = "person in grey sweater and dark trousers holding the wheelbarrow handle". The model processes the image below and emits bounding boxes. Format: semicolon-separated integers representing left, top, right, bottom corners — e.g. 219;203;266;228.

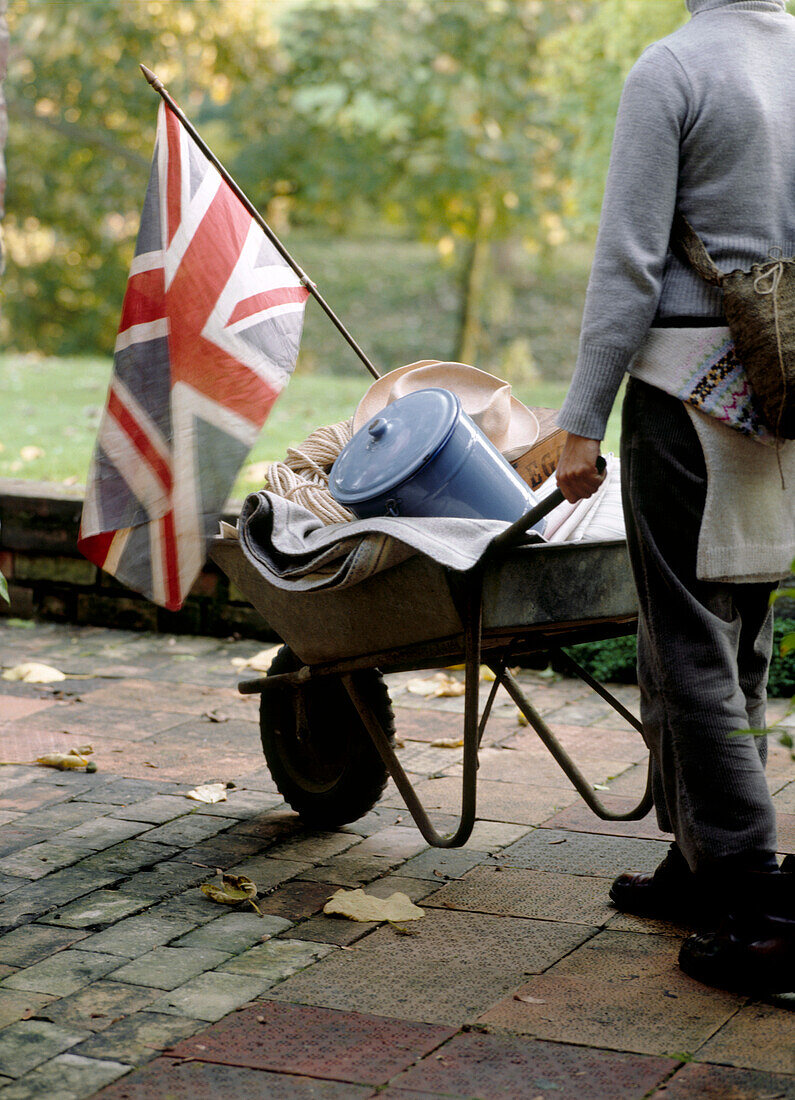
557;0;795;992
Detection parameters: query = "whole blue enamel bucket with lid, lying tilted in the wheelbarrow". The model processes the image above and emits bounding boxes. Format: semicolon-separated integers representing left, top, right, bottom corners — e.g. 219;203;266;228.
329;388;544;531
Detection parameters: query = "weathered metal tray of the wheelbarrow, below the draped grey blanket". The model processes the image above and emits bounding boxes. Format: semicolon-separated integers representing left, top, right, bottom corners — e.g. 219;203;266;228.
210;538;637;664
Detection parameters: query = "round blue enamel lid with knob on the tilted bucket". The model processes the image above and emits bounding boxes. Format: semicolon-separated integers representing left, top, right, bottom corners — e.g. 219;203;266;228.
329;389;461;504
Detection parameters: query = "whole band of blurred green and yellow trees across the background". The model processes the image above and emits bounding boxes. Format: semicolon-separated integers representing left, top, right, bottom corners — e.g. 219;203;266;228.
0;0;703;359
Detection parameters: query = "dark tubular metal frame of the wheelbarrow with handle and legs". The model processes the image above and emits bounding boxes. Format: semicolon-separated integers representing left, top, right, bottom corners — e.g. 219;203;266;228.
221;484;652;848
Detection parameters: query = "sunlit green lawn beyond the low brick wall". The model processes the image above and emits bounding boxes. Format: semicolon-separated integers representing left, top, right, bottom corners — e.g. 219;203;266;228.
0;355;618;498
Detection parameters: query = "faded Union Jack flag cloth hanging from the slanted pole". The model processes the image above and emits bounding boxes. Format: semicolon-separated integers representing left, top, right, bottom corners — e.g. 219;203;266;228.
78;105;308;611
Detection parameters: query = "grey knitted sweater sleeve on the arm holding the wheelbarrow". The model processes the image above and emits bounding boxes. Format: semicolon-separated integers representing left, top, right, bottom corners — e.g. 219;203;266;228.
557;43;689;439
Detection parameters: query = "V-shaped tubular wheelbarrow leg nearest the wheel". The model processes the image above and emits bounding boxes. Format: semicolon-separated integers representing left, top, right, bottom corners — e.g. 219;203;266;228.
342;583;481;848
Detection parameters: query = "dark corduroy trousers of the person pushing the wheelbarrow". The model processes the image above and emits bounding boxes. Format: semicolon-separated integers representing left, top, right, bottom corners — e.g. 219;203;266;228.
621;378;776;872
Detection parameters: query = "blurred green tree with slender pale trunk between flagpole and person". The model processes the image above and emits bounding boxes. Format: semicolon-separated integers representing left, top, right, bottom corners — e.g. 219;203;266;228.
229;0;568;361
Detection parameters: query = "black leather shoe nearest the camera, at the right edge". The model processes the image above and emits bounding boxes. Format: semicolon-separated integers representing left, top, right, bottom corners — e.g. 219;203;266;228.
680;861;795;993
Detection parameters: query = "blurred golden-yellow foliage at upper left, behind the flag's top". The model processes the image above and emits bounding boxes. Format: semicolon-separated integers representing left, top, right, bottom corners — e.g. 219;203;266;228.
0;0;277;354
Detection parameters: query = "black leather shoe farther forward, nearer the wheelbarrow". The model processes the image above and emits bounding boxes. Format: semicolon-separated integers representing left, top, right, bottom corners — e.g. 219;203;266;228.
610;844;703;923
